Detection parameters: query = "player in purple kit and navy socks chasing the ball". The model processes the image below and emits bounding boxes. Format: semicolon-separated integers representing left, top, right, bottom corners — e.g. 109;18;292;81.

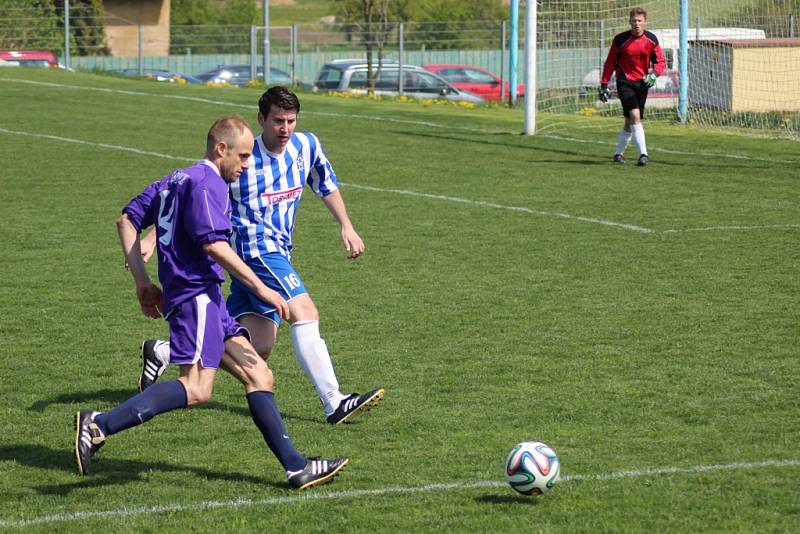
74;117;348;490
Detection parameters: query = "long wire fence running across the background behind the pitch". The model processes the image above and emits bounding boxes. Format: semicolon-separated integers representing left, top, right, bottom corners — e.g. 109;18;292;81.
0;6;798;136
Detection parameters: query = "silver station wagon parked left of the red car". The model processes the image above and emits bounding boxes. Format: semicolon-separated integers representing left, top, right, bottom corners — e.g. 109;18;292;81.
314;59;485;104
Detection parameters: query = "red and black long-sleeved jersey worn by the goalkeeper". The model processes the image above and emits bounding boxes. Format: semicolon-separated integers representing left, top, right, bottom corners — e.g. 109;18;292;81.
600;30;664;83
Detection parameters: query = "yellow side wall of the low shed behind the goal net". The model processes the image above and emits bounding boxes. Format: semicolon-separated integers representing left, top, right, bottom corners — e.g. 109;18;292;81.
731;46;800;113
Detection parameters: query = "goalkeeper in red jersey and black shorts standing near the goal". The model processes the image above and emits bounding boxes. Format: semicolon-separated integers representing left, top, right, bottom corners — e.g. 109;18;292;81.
600;7;664;166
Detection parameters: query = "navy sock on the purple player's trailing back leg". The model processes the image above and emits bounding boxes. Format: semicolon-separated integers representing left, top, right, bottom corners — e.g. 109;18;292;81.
94;380;186;436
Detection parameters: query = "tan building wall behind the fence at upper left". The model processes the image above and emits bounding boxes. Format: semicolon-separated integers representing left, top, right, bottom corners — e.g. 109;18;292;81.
103;0;170;56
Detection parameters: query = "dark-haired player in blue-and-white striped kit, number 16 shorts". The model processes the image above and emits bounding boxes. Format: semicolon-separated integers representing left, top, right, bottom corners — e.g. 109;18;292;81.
139;87;384;425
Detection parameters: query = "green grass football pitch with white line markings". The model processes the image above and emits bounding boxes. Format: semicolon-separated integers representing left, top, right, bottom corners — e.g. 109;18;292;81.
0;69;800;532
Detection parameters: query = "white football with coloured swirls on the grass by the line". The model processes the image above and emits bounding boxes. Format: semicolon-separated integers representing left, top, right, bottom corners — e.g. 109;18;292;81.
506;441;559;495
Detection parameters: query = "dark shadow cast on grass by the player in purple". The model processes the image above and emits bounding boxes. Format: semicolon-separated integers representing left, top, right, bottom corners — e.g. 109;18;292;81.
0;444;288;496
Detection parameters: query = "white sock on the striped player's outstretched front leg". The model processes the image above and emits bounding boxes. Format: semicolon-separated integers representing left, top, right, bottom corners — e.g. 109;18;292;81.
292;321;345;415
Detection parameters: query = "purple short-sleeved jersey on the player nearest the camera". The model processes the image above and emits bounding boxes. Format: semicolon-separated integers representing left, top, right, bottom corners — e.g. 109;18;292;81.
122;160;231;313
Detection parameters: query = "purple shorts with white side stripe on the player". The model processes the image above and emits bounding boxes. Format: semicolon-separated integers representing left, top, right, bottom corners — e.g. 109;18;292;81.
167;285;250;369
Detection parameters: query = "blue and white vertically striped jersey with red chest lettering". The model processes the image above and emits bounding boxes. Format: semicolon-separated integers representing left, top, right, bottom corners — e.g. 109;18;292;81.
230;132;339;259
